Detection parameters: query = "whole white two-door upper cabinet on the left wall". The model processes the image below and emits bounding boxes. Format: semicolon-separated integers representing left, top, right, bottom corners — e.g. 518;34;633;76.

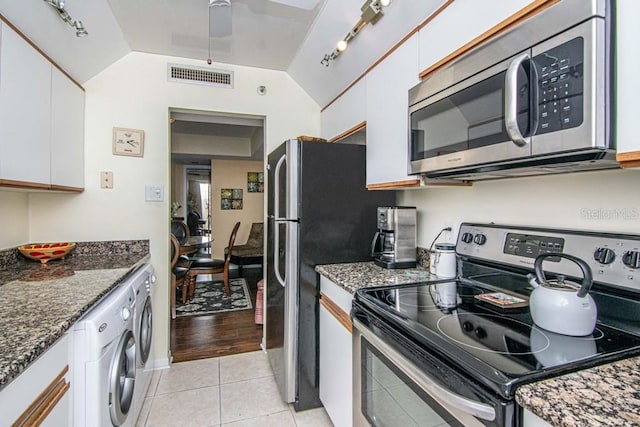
0;20;84;191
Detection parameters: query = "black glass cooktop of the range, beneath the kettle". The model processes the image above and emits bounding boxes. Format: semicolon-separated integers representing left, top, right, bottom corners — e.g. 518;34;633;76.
354;280;640;398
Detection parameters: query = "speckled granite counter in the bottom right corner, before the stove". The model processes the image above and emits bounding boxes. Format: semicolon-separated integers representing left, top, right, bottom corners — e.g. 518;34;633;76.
516;357;640;427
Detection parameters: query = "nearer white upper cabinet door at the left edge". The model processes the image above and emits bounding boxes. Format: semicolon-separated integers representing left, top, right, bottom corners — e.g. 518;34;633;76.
0;25;51;186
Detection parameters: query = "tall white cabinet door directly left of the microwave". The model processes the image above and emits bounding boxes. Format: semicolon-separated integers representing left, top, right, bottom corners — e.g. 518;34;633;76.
366;35;419;185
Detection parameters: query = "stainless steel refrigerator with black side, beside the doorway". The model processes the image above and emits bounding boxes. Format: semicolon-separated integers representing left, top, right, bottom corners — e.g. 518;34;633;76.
266;139;395;411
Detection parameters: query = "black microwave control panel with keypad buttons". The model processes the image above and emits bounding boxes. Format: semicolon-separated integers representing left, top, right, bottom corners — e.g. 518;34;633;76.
533;37;584;135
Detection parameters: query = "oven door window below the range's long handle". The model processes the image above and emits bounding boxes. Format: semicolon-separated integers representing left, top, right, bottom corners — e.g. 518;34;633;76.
360;338;463;427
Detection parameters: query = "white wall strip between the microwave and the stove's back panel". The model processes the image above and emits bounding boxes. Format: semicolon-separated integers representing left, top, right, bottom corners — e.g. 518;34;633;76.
398;170;640;247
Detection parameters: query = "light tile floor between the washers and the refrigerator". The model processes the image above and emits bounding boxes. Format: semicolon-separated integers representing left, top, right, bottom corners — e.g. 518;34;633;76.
136;351;333;427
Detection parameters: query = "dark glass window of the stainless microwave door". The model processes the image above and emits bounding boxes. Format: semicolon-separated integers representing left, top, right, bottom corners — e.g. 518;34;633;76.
411;61;531;160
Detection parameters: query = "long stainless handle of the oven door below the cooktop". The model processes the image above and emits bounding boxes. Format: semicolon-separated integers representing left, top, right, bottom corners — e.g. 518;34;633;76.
353;319;496;421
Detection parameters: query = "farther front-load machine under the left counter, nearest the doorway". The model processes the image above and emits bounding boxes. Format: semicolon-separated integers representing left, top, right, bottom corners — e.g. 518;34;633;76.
131;264;156;418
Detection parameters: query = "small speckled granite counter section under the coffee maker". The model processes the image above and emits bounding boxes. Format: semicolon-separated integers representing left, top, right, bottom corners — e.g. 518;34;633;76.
316;262;438;294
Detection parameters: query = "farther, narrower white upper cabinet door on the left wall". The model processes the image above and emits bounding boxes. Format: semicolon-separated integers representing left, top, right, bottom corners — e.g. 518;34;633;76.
51;67;84;188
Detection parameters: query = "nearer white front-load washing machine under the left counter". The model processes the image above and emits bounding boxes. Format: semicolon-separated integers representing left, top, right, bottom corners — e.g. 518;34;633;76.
73;280;137;427
